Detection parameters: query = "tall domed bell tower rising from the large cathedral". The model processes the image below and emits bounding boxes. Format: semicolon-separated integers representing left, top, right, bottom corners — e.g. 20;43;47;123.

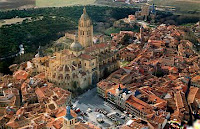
78;8;93;47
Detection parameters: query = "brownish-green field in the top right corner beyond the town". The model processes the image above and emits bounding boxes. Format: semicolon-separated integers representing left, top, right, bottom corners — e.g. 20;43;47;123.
154;0;200;13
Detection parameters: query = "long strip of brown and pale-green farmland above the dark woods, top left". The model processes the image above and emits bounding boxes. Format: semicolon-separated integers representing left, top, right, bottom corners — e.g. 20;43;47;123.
0;0;137;10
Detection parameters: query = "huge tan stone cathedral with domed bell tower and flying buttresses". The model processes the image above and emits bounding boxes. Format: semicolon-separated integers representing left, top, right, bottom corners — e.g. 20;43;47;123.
32;8;119;90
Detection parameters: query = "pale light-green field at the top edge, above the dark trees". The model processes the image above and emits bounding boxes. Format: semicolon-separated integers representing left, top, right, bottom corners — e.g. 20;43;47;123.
36;0;95;7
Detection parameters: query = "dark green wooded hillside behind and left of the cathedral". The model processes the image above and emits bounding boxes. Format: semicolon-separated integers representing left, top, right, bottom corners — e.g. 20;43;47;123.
0;6;136;73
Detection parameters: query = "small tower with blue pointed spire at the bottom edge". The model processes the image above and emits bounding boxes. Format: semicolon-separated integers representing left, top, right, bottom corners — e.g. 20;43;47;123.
62;106;76;129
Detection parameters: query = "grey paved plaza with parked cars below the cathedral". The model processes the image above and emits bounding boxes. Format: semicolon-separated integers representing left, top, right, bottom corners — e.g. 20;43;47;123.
72;88;128;129
